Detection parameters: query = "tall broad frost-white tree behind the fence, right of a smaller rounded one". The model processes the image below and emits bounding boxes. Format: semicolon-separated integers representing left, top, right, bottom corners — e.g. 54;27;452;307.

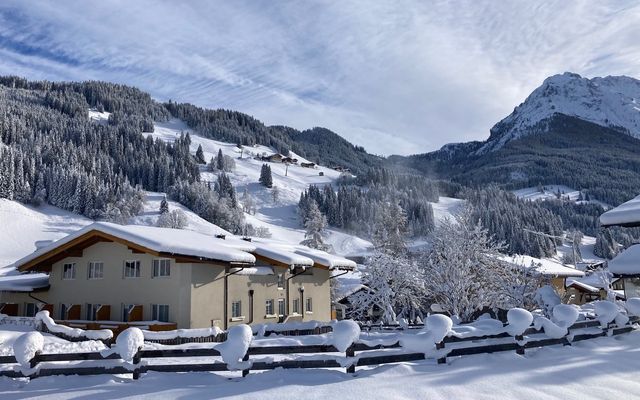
422;209;512;321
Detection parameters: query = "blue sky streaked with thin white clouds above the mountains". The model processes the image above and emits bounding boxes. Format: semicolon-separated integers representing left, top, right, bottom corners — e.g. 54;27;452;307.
0;0;640;155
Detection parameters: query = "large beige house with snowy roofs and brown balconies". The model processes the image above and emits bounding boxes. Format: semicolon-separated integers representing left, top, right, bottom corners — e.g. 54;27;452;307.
0;222;356;329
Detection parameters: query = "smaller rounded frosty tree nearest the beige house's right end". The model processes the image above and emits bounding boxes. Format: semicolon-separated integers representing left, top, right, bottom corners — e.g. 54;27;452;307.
350;251;424;323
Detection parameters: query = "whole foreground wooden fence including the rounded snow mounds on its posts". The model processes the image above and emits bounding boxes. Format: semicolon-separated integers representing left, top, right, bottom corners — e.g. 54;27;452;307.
0;313;640;379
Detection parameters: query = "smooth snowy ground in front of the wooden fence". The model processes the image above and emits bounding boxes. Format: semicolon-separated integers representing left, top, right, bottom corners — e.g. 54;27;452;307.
0;333;640;400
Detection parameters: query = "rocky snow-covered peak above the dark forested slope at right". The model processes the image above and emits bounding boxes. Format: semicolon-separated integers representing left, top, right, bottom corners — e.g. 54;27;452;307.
479;72;640;153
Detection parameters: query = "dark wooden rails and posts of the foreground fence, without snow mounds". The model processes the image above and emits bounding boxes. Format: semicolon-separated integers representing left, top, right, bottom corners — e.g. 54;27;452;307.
0;317;640;379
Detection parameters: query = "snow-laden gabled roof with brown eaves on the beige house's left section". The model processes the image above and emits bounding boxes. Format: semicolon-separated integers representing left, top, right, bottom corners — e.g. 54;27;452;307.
14;222;256;267
